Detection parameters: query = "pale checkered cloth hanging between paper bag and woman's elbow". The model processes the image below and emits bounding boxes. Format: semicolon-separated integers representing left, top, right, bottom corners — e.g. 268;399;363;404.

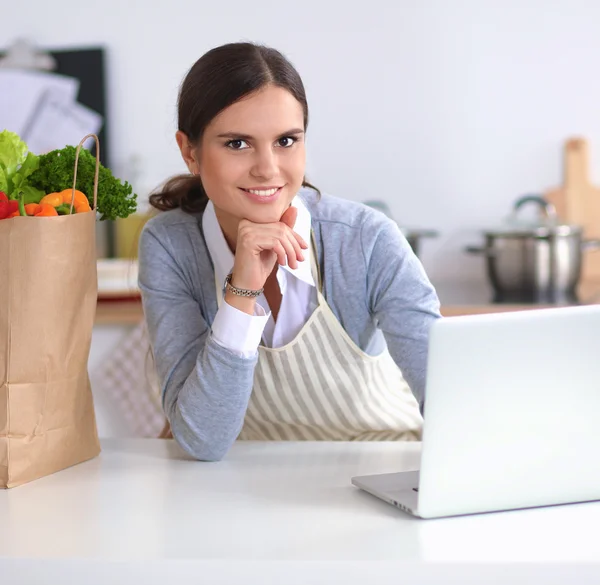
93;321;166;437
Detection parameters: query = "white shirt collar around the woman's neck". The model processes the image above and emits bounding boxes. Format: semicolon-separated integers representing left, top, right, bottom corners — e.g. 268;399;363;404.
202;195;316;286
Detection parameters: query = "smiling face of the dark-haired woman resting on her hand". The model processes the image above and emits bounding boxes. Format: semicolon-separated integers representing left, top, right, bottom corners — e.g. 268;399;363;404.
178;86;306;237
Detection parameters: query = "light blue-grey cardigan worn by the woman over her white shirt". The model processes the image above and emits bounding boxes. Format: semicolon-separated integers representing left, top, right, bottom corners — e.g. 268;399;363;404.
139;188;440;461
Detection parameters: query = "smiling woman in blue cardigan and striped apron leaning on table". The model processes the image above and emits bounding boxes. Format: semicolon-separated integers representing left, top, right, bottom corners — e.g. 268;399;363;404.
139;43;440;460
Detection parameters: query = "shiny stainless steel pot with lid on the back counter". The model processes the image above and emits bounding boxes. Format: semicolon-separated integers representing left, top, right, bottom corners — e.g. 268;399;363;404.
466;195;600;304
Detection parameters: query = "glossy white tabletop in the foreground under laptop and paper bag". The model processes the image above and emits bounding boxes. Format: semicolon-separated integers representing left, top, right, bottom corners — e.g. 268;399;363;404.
0;439;600;585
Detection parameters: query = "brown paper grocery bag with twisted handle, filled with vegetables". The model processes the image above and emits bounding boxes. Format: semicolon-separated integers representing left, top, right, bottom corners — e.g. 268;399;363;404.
0;135;100;488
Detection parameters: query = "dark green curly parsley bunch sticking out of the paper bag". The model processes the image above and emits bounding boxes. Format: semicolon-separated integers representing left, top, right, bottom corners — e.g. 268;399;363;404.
28;146;137;220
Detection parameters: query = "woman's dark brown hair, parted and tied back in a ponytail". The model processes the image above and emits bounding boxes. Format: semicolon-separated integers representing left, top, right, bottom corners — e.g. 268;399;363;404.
149;43;320;212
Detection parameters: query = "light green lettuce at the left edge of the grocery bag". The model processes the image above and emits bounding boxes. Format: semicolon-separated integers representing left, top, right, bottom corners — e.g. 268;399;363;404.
0;130;43;201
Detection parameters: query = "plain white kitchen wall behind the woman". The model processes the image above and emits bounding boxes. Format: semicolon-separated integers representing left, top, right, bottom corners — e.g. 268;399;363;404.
2;0;600;282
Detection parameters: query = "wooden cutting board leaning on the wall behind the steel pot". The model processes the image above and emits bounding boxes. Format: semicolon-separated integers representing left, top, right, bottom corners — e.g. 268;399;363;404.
545;138;600;283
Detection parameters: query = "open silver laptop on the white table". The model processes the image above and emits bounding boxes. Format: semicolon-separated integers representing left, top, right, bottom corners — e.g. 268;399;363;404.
352;305;600;518
